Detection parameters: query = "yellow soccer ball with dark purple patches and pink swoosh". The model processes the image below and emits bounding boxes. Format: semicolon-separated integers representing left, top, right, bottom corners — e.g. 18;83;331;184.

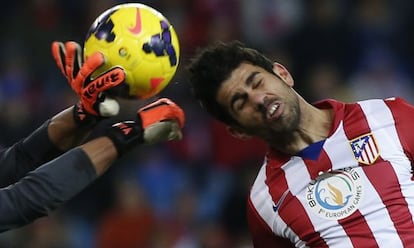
84;3;180;99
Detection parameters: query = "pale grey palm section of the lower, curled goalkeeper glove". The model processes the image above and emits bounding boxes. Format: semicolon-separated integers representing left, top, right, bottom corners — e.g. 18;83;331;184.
144;121;182;144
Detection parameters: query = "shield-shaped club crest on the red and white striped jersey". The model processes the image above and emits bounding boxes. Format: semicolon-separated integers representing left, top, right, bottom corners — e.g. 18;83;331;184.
349;133;379;165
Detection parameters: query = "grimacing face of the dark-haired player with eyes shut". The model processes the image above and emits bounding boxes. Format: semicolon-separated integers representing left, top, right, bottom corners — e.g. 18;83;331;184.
217;63;300;139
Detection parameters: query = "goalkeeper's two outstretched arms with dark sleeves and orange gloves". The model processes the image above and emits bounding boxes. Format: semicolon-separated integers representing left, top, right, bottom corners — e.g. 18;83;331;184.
0;42;184;232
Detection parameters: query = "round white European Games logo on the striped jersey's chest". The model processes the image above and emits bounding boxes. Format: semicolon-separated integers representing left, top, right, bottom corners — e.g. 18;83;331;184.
306;168;364;220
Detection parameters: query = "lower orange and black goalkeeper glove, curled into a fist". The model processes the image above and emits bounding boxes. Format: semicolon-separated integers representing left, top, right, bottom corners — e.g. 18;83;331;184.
106;98;185;156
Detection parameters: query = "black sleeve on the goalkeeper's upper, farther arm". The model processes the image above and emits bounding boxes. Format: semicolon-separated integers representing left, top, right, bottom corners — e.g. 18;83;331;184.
0;120;61;187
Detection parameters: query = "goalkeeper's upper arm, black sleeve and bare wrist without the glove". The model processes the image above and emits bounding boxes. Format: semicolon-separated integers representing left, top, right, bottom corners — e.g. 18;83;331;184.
0;107;96;187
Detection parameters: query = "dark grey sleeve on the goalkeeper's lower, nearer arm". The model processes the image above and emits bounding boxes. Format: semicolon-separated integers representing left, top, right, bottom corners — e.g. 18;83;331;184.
0;148;97;232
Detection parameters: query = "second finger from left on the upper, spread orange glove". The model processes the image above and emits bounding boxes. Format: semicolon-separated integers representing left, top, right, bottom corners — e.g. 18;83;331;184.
65;41;82;82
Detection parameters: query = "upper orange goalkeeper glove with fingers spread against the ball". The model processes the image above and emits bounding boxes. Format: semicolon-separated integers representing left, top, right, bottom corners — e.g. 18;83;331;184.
52;41;125;125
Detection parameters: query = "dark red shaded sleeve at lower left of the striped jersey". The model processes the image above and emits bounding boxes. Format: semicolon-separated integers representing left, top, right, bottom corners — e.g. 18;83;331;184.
247;198;295;248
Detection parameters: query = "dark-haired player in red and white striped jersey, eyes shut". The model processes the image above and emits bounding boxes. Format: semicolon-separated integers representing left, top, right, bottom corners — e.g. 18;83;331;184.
189;42;414;248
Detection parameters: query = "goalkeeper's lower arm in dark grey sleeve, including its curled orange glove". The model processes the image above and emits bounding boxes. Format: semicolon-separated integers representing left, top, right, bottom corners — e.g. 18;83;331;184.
0;99;184;232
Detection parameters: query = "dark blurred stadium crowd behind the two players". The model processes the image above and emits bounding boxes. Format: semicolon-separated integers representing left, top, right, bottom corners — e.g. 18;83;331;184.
0;0;414;248
